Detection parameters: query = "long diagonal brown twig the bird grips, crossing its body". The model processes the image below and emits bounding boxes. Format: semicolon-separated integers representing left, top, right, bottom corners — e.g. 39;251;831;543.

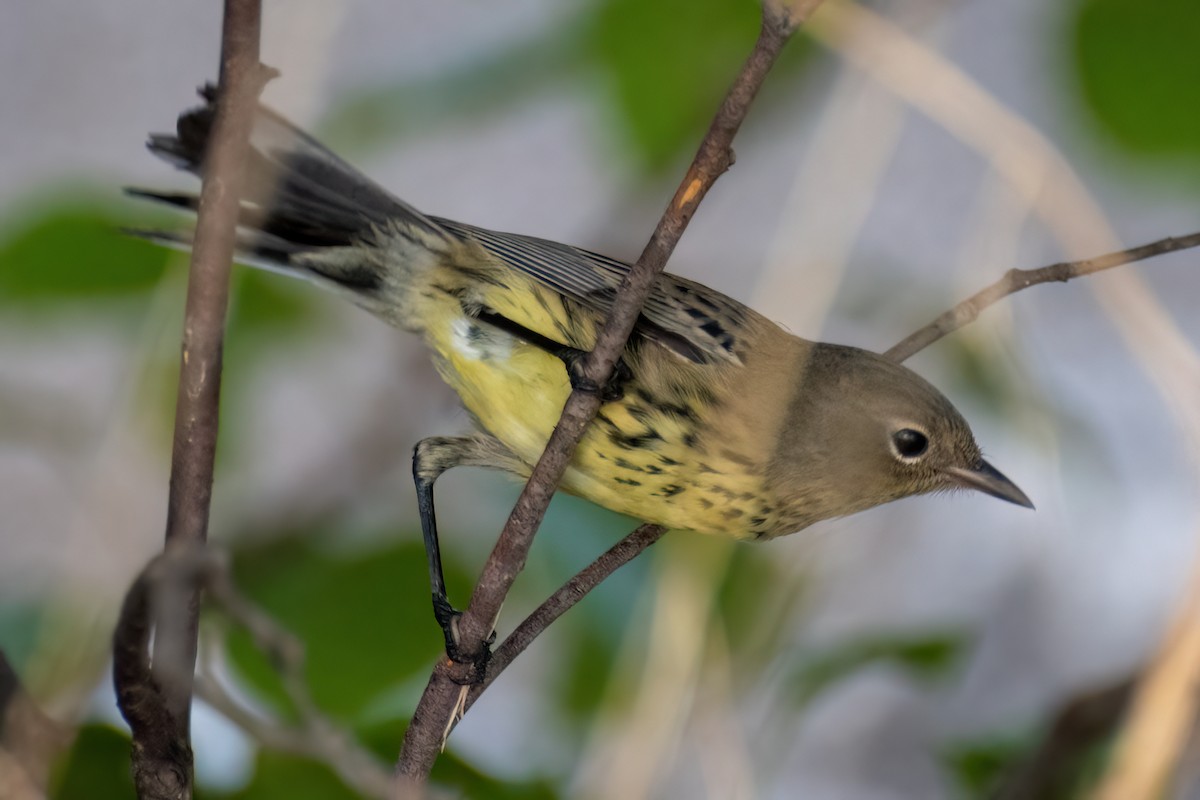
396;0;820;795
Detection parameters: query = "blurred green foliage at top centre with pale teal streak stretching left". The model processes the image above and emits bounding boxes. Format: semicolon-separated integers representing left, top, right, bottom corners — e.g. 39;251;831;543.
323;0;810;175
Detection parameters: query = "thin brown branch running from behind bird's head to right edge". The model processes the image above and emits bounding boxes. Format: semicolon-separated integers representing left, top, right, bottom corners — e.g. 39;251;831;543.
883;233;1200;361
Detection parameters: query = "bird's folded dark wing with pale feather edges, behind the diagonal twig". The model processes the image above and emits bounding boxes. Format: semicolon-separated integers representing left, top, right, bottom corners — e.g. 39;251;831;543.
431;217;754;363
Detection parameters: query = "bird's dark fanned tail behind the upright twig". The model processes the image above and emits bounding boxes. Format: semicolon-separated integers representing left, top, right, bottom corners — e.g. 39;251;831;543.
126;85;454;327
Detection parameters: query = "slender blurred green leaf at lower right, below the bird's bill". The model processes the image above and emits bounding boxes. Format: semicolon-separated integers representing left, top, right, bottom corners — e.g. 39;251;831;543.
793;633;965;703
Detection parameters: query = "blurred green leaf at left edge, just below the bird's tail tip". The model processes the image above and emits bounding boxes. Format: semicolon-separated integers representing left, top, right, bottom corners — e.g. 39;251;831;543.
0;201;170;302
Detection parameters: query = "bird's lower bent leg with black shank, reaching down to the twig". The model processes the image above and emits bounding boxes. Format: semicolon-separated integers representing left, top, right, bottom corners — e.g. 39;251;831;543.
413;435;515;679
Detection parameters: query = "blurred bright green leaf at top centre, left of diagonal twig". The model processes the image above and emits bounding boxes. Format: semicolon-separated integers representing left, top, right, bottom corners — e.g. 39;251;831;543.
584;0;760;168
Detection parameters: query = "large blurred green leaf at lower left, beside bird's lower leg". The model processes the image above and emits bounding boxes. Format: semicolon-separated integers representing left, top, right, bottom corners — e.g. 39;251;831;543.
230;533;468;720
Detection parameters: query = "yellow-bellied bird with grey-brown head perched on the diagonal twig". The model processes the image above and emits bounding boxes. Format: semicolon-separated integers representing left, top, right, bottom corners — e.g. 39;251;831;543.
127;85;1033;652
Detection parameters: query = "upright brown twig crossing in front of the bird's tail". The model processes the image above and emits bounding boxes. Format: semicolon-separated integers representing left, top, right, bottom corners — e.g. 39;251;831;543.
130;0;270;796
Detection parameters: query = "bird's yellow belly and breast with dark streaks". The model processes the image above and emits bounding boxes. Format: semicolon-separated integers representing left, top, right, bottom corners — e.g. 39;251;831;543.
425;286;772;537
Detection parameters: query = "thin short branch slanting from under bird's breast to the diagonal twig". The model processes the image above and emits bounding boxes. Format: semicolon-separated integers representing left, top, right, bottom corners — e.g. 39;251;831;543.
463;523;667;712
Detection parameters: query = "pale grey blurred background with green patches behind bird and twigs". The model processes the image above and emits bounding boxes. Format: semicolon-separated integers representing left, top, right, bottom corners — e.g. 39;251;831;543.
0;0;1200;800
